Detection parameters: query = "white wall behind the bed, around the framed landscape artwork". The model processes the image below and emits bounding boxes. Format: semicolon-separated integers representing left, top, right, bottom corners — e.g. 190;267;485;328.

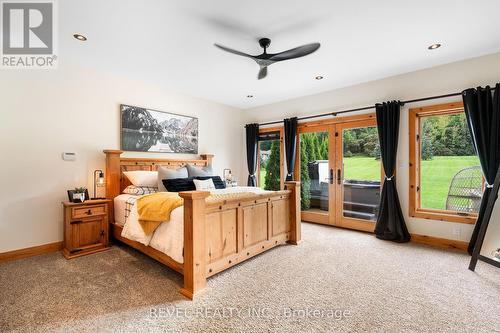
0;63;245;253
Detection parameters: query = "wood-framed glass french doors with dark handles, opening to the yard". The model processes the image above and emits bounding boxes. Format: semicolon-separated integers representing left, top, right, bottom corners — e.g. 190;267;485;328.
296;117;383;232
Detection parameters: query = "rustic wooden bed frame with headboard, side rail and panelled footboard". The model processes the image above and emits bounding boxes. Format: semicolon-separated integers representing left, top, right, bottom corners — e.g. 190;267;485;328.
104;150;301;299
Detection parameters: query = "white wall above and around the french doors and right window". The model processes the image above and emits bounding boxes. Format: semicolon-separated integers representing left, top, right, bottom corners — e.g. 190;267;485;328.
246;53;500;248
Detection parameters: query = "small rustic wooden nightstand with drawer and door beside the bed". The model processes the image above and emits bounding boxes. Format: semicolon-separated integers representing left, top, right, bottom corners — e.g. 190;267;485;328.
62;199;111;259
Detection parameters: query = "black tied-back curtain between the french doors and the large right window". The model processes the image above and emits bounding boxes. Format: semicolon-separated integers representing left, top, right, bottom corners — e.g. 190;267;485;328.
375;101;410;243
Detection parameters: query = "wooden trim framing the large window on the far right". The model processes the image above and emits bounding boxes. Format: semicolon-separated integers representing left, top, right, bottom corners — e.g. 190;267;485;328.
409;102;477;224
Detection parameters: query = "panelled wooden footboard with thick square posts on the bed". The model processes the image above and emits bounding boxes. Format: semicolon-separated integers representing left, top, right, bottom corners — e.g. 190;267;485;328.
180;182;301;299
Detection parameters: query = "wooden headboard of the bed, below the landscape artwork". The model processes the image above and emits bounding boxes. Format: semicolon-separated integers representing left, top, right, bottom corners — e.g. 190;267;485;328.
104;150;214;199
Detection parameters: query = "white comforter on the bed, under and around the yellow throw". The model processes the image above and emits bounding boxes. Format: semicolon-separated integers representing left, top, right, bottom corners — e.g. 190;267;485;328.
115;186;266;263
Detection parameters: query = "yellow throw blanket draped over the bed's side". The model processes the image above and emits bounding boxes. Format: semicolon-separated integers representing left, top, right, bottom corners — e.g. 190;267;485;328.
136;192;184;235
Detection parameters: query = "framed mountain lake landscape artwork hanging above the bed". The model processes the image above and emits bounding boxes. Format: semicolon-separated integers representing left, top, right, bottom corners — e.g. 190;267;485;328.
120;104;198;154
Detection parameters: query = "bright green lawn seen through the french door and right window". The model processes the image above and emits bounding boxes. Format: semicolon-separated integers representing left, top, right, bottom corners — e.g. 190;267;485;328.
344;156;479;209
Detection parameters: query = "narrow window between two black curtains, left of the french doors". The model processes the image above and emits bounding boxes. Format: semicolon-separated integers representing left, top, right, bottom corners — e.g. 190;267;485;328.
257;128;284;191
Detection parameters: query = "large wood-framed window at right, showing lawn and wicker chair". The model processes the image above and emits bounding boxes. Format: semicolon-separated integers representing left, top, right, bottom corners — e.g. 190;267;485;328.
410;103;484;224
